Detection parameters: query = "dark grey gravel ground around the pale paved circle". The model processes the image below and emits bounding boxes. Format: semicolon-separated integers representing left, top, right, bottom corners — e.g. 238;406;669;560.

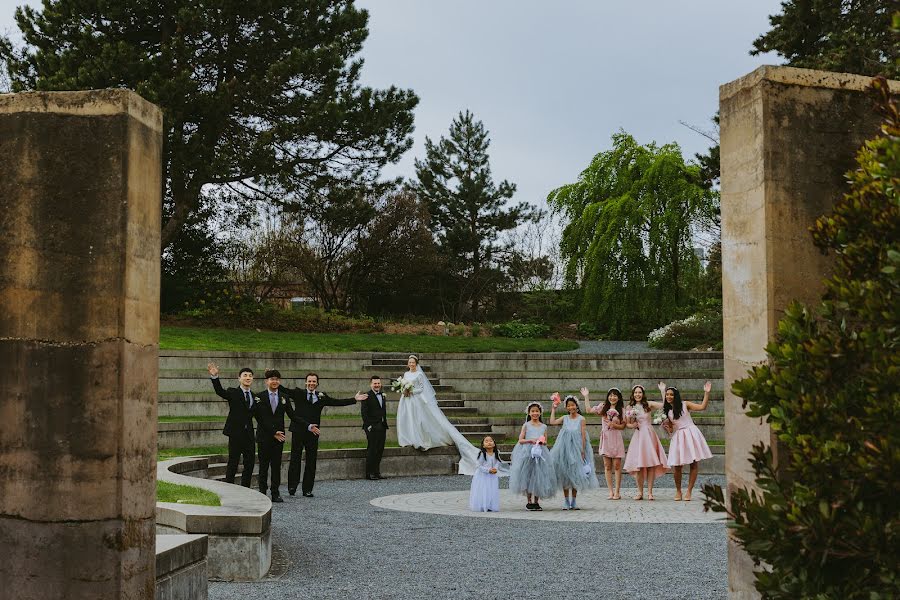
209;475;727;600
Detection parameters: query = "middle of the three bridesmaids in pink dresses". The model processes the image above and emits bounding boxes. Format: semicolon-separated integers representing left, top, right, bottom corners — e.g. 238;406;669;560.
624;385;669;500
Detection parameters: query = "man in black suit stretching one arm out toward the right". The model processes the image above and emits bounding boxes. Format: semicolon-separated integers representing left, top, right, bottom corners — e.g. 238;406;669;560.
282;373;367;498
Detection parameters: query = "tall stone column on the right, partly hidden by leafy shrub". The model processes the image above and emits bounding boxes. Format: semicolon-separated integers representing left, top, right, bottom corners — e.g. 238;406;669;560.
719;67;900;599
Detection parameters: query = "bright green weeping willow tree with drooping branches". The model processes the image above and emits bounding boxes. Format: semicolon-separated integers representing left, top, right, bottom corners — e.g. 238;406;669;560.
547;132;718;335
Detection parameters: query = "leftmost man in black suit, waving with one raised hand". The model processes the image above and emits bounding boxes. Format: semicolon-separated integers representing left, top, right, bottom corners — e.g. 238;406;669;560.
206;363;254;487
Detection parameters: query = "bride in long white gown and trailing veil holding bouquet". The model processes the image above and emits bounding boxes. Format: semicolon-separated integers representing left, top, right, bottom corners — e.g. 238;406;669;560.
397;355;478;475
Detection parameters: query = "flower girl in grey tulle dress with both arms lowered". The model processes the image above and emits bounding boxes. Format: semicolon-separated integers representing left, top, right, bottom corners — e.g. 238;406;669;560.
509;402;556;510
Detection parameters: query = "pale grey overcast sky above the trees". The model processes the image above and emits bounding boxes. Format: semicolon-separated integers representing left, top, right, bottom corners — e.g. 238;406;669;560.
0;0;780;209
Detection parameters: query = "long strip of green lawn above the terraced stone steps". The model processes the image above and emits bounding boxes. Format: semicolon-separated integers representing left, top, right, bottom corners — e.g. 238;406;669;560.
159;326;578;352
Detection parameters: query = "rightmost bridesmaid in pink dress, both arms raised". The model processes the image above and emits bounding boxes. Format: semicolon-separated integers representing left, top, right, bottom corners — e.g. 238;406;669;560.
659;381;712;501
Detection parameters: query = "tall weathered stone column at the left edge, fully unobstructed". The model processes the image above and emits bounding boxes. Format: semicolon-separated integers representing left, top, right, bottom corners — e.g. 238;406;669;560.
0;90;162;600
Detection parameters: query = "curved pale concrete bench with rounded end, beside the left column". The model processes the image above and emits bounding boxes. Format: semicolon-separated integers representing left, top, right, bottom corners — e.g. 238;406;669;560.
156;457;272;581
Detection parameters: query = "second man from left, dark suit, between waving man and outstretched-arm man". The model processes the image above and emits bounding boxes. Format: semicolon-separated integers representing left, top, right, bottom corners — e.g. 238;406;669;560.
253;369;294;502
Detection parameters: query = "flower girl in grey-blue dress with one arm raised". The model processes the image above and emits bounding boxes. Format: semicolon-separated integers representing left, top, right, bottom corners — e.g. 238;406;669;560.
550;393;599;510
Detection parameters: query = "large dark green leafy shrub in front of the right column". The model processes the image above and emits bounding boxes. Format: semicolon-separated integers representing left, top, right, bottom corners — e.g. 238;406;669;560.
703;79;900;600
